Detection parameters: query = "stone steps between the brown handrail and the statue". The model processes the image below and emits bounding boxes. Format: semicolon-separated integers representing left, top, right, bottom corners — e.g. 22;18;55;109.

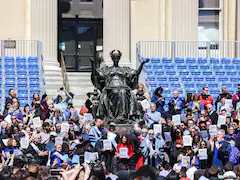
68;72;94;109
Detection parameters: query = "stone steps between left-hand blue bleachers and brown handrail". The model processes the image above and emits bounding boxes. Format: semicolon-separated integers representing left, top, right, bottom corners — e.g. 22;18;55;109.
44;61;63;103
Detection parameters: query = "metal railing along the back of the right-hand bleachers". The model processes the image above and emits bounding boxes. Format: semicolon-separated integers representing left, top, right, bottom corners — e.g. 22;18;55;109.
137;41;240;59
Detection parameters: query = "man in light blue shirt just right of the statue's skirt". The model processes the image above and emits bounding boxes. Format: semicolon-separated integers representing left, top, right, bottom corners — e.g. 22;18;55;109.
144;103;161;128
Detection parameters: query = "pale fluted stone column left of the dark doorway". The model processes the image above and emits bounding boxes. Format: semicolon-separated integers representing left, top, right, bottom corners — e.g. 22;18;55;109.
31;0;58;62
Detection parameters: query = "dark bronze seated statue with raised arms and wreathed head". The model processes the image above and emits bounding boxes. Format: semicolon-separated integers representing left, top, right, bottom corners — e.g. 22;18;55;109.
91;50;149;124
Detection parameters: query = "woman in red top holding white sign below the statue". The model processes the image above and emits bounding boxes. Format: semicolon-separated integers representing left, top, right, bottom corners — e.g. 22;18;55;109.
115;134;133;169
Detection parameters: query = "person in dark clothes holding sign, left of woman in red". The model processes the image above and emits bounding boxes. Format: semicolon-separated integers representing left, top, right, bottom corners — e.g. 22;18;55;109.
96;131;116;173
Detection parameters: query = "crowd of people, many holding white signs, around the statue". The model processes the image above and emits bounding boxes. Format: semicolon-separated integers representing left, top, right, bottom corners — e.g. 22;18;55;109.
0;84;240;180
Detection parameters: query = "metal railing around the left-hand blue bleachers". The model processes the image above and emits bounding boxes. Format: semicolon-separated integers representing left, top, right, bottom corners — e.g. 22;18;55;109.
0;39;46;110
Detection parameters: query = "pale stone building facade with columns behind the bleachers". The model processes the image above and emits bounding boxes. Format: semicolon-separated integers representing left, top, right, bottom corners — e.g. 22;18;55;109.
0;0;240;71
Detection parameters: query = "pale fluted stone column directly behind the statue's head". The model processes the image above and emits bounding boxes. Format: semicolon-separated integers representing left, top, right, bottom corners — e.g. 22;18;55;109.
103;0;130;65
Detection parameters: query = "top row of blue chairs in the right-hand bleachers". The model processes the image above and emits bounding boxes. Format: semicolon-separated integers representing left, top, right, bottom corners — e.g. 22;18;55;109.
142;57;240;64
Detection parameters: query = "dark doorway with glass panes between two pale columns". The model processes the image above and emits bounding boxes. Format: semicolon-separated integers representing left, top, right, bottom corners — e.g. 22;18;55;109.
59;18;103;72
